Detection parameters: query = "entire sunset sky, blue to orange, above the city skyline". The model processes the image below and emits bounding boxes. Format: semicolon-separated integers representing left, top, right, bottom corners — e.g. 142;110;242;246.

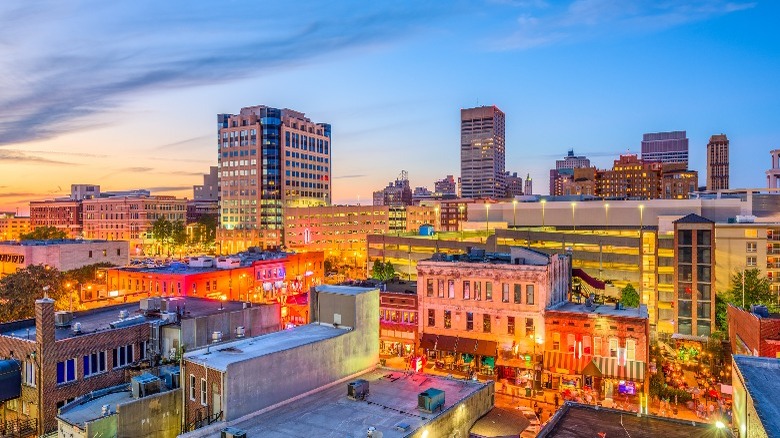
0;0;780;213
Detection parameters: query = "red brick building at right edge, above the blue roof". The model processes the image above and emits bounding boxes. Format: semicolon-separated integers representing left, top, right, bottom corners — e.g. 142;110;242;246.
727;304;780;359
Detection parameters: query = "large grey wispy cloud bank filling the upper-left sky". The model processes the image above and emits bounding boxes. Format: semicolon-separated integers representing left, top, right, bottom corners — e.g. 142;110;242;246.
0;0;448;147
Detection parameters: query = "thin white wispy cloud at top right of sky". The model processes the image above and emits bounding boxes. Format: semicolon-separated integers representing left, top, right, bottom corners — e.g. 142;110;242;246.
493;0;756;50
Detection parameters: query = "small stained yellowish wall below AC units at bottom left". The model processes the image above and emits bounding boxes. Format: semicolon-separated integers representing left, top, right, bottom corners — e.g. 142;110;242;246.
116;389;182;438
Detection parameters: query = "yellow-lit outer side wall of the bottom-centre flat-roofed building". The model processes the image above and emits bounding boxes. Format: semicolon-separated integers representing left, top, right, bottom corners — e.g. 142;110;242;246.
406;381;495;438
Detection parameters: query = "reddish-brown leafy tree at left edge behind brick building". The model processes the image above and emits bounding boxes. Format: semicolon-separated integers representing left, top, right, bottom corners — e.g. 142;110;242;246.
0;265;68;322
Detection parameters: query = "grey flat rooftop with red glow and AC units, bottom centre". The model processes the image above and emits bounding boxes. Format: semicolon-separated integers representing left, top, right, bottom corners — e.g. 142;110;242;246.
222;368;486;438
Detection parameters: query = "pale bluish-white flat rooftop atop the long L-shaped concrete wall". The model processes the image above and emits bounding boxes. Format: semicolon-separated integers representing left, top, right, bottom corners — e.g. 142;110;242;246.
184;323;347;371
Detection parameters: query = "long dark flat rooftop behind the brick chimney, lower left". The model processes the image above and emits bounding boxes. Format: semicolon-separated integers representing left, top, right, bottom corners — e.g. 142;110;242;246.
0;297;250;341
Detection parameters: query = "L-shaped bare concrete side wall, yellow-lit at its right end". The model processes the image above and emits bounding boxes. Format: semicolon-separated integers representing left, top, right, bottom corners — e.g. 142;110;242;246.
223;290;379;421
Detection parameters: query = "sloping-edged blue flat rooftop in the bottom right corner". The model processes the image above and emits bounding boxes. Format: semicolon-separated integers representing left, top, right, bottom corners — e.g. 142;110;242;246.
733;355;780;436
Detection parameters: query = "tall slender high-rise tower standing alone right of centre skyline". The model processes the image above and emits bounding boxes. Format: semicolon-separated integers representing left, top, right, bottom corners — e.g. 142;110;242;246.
460;105;506;199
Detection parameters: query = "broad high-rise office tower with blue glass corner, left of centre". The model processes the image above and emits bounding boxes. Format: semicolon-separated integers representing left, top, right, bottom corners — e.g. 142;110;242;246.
217;105;331;230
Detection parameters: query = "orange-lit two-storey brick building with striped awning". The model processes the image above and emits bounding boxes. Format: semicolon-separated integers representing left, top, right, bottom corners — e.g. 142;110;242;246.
542;303;650;398
